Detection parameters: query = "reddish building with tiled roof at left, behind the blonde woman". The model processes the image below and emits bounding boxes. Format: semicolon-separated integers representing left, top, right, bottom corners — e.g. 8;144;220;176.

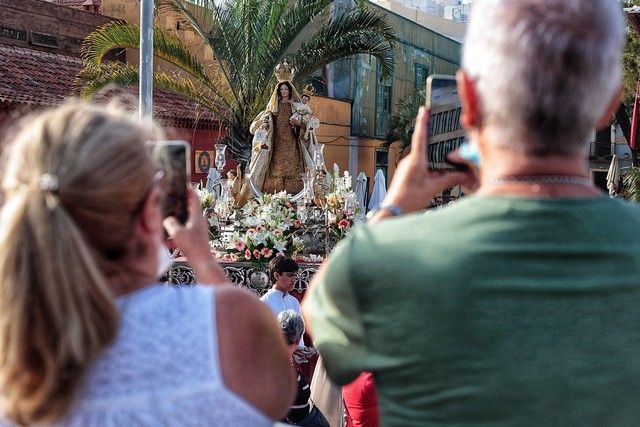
0;0;224;184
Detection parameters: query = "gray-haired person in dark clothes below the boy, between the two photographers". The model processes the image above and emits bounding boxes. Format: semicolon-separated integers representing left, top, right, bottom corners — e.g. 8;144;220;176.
277;309;329;427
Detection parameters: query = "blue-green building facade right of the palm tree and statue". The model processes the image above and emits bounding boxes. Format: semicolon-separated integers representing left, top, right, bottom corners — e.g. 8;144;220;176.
325;0;461;187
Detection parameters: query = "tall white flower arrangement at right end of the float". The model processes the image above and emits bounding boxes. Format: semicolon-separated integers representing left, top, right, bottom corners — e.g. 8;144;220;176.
326;168;360;240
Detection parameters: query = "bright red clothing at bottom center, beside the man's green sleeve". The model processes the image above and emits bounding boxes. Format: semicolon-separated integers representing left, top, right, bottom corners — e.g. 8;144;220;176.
342;372;380;427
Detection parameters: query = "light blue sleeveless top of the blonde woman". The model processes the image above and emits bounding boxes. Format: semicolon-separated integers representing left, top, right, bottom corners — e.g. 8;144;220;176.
0;285;273;427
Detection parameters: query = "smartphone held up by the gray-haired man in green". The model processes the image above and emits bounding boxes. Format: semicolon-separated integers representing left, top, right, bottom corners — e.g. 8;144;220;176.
425;74;468;171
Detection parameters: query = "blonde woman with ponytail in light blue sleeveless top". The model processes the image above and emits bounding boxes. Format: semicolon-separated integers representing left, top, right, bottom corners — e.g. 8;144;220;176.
0;105;295;426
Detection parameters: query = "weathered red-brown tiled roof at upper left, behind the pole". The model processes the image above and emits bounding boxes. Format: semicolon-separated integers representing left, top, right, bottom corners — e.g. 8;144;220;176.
0;44;217;128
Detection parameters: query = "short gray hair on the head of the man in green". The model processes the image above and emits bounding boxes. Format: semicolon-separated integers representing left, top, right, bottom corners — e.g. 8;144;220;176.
462;0;624;157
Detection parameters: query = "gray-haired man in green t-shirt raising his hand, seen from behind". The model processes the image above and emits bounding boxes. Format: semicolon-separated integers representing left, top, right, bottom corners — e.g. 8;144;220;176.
303;0;640;426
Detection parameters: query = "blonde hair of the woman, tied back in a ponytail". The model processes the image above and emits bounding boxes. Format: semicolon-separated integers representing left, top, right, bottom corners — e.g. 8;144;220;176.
0;104;154;424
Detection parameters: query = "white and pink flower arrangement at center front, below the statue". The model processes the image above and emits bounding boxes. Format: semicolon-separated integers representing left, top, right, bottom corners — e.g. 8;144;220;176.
218;192;304;264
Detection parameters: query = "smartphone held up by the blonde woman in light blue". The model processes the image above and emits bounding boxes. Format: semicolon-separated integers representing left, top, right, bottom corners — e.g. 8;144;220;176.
148;141;191;224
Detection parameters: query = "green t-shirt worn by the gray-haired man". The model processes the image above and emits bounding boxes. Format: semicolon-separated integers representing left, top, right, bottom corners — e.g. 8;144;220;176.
307;196;640;426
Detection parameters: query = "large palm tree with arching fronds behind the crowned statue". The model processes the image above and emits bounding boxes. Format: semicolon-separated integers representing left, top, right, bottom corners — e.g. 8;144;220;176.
78;0;395;161
